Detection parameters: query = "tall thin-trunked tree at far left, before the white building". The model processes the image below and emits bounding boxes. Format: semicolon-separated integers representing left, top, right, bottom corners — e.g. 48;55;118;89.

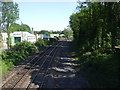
2;2;19;48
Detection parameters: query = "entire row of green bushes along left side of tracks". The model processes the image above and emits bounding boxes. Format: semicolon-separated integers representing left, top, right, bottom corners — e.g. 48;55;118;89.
1;39;58;75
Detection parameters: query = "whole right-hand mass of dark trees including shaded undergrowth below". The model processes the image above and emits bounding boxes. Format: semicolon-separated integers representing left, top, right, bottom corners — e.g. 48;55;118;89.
70;2;120;88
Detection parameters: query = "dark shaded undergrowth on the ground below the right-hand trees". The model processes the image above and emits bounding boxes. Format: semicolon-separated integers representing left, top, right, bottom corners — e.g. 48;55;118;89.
72;39;120;88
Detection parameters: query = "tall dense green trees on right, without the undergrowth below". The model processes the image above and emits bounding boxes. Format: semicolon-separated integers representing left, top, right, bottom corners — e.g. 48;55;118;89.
70;2;120;53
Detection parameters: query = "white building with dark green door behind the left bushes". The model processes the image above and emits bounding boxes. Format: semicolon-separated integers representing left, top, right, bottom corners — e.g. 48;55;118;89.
1;31;36;49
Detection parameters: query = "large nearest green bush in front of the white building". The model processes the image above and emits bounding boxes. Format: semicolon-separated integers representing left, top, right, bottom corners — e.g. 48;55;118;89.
1;41;38;71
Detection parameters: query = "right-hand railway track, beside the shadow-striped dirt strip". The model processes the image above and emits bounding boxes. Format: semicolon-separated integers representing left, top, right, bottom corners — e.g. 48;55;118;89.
26;41;62;90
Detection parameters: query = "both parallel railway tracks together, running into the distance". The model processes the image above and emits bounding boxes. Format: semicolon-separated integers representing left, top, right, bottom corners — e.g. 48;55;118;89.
2;43;61;90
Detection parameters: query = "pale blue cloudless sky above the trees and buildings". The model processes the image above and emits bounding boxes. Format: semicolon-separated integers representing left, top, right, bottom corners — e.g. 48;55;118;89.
17;1;78;31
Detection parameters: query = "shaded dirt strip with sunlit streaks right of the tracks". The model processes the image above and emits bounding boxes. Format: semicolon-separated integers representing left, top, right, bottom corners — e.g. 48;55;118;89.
44;42;88;88
